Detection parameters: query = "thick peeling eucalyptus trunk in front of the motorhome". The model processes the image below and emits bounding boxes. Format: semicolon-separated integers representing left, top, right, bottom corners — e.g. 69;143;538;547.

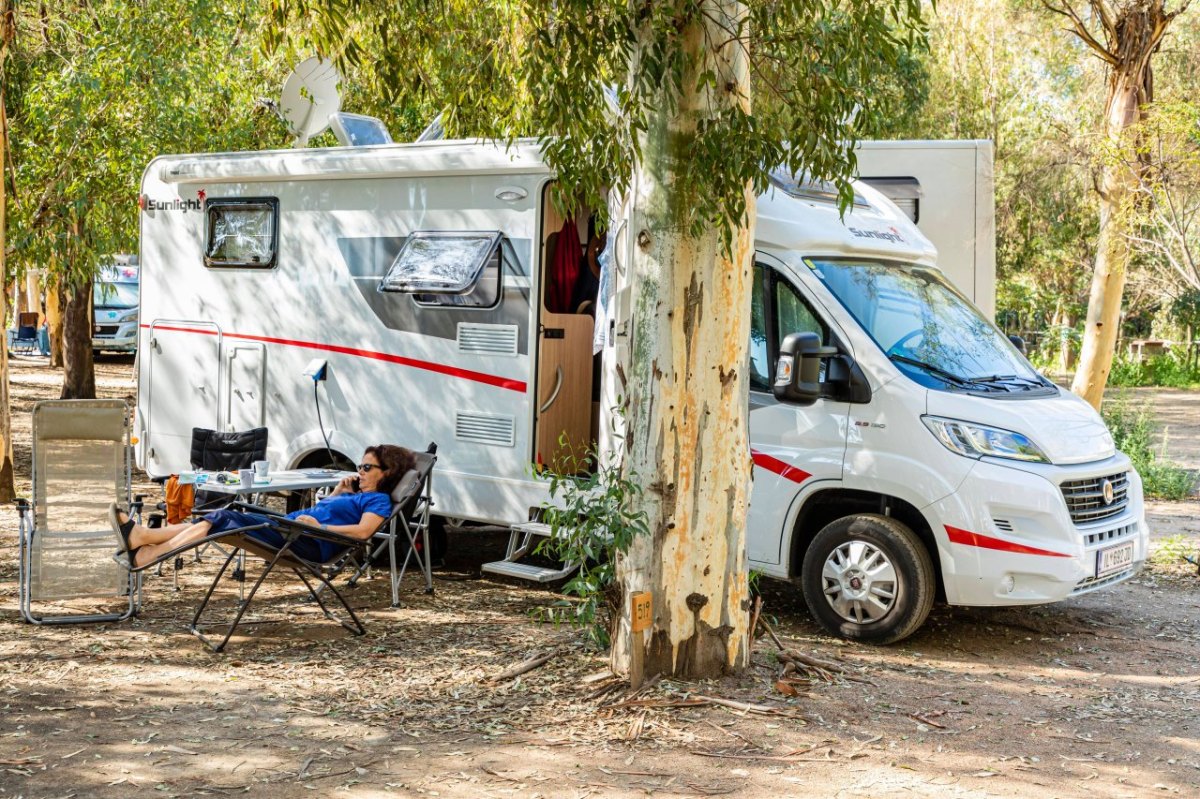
612;0;755;678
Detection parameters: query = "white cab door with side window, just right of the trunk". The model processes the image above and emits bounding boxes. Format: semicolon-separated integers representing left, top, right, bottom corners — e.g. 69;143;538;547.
746;253;853;564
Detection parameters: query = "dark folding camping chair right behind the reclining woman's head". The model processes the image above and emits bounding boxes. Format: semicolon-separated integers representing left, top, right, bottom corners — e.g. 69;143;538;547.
349;443;438;607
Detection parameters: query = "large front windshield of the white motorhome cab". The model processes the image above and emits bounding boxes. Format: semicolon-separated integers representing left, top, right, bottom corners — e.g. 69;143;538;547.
808;258;1056;394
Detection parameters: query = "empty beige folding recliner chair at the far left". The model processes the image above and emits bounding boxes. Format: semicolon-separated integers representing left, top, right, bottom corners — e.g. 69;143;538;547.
17;400;140;624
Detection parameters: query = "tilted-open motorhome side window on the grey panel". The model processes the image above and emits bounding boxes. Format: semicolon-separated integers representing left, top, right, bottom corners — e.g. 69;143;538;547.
379;230;503;308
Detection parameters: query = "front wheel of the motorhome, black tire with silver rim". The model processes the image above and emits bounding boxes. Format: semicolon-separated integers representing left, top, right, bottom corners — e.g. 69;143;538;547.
800;513;937;644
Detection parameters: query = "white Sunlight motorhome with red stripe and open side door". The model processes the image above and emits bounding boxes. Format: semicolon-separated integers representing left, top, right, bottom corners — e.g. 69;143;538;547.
136;142;1147;642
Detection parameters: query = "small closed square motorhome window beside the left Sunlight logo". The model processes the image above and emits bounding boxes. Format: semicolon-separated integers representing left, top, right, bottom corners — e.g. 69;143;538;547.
204;197;280;269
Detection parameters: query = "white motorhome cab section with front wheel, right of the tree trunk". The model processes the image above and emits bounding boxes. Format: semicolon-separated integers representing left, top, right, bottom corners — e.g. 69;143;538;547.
734;171;1148;642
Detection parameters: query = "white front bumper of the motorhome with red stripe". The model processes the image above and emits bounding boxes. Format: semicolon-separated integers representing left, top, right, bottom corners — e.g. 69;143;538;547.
929;453;1150;606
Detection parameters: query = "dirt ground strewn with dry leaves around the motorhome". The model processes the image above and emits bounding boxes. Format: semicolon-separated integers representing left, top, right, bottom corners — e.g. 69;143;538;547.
0;359;1200;799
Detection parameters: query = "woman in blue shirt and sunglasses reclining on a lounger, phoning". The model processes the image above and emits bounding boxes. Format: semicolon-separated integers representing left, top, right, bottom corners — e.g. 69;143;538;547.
109;444;416;567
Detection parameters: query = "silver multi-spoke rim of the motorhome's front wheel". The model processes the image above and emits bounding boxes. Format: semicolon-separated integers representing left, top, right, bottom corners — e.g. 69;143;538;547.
821;541;899;624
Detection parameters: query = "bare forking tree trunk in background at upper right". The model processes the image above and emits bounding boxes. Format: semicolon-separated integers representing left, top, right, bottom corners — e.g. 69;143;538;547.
1043;0;1190;409
